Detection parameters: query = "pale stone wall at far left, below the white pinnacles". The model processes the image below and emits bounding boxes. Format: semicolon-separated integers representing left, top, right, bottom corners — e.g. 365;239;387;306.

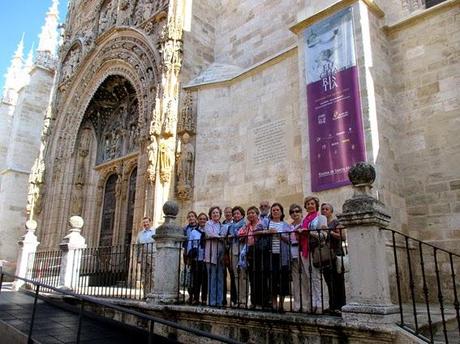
0;67;54;272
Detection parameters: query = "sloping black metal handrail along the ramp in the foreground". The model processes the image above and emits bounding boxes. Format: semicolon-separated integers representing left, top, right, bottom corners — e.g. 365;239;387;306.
0;267;240;344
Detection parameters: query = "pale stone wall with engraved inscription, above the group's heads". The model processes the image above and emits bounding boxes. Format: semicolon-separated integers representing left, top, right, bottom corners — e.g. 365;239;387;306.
190;52;304;211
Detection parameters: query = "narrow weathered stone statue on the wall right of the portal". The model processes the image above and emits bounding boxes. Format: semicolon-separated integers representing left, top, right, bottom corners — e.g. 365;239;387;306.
176;133;195;200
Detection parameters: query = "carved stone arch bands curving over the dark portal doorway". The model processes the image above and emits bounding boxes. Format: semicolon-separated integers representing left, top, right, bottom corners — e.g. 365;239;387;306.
54;30;161;160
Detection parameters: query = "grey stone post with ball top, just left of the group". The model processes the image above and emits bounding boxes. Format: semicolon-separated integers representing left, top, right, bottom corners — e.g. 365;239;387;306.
147;201;185;304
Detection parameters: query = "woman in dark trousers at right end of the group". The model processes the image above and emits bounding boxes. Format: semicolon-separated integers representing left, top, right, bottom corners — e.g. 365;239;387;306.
321;203;346;313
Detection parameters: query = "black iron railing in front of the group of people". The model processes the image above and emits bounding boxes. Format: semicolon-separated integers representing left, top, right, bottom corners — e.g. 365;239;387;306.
178;229;348;315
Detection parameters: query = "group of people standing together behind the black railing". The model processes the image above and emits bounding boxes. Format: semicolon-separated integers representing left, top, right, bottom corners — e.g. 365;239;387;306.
184;196;345;313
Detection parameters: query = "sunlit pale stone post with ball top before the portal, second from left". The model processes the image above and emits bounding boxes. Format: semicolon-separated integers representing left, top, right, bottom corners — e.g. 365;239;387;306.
59;216;86;289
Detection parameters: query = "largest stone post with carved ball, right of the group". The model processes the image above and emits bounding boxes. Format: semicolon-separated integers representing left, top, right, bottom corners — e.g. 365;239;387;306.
338;162;398;323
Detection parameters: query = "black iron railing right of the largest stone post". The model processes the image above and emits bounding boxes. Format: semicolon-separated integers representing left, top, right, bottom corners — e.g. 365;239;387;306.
387;229;460;343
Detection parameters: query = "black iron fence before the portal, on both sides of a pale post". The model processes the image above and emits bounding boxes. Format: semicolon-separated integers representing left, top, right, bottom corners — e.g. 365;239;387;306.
27;243;155;300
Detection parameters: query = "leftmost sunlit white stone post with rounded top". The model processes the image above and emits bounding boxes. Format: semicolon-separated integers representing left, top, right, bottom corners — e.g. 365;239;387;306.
13;220;40;290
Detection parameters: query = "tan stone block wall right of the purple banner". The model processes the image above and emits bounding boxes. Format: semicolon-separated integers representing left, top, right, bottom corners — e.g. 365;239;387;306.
388;6;460;252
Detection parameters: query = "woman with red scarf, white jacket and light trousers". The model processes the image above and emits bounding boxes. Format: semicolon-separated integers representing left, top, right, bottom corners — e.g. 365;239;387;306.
299;196;327;314
